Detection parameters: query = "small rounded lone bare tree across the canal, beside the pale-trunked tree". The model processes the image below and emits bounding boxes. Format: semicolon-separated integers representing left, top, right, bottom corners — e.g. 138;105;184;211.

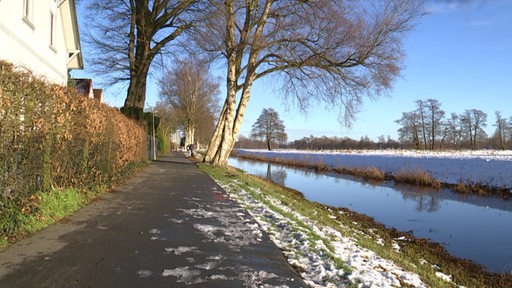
251;108;288;150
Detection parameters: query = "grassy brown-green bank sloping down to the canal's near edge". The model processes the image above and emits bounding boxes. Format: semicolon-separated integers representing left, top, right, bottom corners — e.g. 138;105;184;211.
200;165;512;287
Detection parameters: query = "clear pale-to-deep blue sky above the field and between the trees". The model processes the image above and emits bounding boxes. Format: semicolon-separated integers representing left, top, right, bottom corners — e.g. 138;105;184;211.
73;0;512;140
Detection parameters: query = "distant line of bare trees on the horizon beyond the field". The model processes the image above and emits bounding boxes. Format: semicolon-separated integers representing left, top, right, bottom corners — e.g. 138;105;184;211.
235;99;512;150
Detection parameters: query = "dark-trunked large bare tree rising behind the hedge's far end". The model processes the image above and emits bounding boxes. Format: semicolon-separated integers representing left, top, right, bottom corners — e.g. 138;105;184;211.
83;0;206;120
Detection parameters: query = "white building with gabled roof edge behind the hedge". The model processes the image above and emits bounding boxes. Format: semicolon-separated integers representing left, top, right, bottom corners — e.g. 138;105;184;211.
0;0;83;85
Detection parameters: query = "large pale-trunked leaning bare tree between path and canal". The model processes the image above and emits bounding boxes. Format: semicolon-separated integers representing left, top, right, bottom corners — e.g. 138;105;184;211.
194;0;422;166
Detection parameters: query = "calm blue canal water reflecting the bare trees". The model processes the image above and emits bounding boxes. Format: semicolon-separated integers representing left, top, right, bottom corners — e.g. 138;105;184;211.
228;158;512;273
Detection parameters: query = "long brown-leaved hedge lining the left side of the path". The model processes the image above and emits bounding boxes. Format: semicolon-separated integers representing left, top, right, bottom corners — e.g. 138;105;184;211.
0;61;147;238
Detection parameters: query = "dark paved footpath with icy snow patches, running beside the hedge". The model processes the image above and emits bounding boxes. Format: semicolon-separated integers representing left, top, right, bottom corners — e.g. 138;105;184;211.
0;152;306;288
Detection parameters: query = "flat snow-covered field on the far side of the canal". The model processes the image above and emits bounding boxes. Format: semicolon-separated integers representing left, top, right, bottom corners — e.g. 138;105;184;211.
237;149;512;189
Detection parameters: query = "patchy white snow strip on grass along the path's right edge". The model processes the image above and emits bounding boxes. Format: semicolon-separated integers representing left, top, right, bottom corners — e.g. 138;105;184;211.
218;181;444;287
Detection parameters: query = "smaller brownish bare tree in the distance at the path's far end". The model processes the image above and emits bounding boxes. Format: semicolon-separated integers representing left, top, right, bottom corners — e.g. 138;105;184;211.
159;58;219;145
